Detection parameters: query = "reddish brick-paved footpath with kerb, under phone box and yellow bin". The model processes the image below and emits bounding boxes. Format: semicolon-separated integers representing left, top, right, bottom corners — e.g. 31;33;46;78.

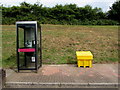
6;64;120;88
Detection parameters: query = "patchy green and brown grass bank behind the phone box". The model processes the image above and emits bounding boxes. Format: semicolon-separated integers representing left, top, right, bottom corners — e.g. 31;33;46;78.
2;25;118;67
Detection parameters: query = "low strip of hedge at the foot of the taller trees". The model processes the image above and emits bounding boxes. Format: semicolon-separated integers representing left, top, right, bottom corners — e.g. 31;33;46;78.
2;17;120;25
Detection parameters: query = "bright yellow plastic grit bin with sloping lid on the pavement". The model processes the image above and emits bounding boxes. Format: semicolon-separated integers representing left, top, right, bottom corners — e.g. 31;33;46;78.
76;51;93;68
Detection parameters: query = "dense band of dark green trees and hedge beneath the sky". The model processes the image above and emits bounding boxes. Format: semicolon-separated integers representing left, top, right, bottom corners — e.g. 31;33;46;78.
2;1;120;25
